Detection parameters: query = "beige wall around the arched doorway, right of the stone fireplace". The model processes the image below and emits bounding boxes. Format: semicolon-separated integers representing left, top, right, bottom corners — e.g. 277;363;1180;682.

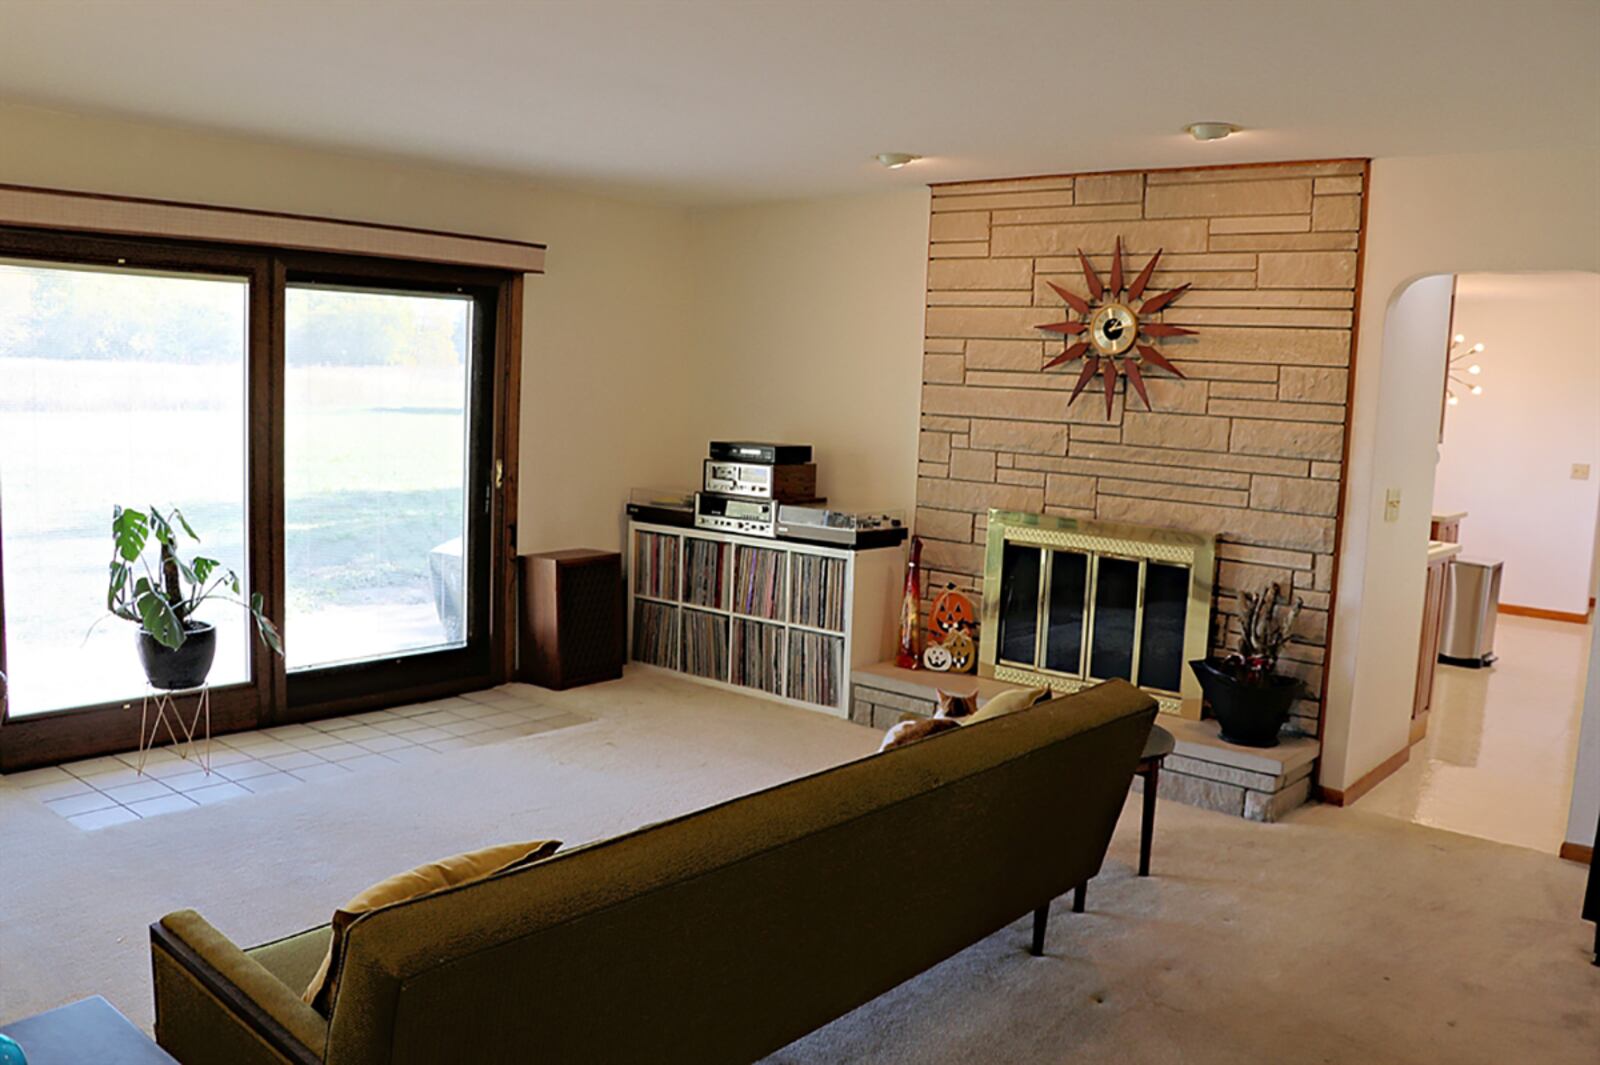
1320;152;1600;790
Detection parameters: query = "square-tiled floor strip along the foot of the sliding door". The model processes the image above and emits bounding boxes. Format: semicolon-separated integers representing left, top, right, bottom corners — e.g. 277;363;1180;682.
0;684;590;828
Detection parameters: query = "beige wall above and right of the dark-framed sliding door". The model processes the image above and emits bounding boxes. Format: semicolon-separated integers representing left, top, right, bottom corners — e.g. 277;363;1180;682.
0;106;704;552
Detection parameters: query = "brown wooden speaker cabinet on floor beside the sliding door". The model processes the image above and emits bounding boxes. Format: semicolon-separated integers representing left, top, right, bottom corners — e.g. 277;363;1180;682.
517;548;624;689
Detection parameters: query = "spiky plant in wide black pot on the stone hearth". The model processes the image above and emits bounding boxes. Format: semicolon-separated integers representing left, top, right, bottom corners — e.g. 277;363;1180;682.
1189;582;1304;747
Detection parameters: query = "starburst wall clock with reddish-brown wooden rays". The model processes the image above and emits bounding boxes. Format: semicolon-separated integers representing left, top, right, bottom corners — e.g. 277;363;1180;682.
1035;237;1194;421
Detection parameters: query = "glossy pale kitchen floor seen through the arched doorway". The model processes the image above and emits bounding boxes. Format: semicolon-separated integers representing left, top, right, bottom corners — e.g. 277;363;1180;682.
1355;614;1590;854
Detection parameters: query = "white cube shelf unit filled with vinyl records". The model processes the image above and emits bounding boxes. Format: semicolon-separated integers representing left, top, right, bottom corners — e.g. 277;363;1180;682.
627;521;906;718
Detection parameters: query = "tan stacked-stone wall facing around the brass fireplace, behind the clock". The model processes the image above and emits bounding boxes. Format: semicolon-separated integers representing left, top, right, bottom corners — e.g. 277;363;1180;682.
917;162;1366;731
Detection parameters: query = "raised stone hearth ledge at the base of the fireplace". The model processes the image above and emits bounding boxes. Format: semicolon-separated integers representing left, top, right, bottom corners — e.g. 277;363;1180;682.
850;662;1320;820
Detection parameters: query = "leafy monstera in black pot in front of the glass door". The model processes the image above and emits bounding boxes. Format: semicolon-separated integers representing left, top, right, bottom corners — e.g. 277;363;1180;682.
106;507;283;691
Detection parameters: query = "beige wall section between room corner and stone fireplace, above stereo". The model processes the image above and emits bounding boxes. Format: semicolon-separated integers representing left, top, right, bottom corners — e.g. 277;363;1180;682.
674;189;928;518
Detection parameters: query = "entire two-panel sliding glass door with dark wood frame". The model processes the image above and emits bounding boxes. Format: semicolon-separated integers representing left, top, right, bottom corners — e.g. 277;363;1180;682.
0;230;520;769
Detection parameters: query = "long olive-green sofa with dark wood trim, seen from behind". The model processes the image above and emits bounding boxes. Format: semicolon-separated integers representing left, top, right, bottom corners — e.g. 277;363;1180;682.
150;681;1155;1065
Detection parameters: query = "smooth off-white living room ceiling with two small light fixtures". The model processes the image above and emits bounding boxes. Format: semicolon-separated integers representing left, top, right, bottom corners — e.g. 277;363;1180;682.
0;0;1600;201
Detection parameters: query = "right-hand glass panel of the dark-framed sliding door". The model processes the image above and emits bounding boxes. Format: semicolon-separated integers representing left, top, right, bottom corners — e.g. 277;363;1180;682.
283;278;493;697
